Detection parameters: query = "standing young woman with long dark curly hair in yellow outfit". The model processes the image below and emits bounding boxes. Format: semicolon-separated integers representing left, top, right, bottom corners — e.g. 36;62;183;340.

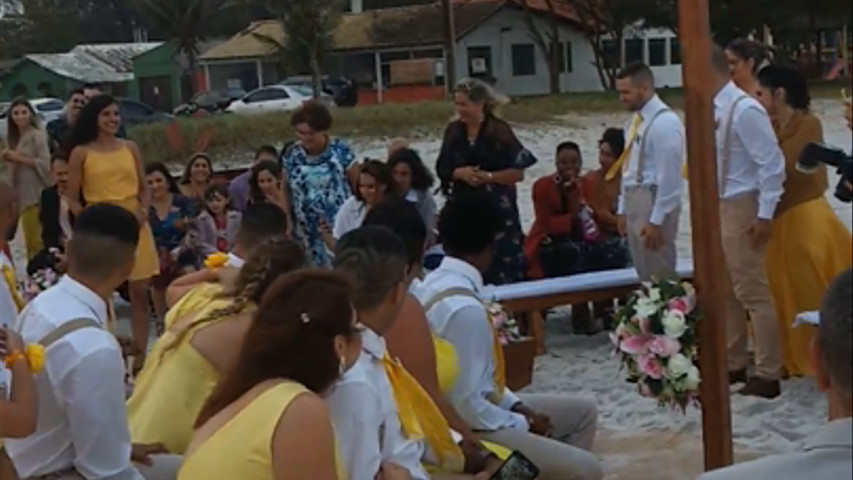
67;95;160;369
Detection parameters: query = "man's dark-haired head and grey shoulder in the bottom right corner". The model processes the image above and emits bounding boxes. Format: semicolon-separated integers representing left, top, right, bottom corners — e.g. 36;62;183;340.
700;270;853;480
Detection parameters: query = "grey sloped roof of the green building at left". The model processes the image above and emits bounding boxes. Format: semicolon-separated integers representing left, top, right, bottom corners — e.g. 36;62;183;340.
24;42;162;83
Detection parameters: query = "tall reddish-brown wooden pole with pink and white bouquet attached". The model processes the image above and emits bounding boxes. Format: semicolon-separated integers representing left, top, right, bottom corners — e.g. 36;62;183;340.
678;0;732;470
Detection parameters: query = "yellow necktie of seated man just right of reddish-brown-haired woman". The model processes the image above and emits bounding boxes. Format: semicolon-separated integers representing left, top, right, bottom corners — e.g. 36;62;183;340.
382;352;465;472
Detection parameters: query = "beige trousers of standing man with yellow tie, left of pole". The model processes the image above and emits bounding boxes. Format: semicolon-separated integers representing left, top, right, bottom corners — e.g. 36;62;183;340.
625;187;681;281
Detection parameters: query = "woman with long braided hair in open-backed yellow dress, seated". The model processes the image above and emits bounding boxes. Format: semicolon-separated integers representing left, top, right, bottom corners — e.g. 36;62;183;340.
127;239;306;455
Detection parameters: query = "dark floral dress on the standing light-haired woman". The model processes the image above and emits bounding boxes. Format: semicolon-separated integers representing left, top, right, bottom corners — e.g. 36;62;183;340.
436;115;536;285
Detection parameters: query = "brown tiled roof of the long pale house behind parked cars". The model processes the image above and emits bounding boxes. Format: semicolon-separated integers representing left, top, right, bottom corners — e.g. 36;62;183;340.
201;0;577;61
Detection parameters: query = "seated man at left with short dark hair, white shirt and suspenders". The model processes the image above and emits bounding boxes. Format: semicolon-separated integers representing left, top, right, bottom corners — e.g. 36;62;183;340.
6;205;177;480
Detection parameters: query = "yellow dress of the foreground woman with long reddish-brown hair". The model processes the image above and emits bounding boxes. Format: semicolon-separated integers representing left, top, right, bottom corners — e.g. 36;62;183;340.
178;382;346;480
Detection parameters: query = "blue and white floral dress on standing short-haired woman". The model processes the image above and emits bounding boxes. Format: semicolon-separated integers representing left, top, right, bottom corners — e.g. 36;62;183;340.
283;139;355;267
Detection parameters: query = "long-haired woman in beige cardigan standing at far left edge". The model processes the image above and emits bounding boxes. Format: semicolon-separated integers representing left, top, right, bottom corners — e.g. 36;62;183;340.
0;98;52;259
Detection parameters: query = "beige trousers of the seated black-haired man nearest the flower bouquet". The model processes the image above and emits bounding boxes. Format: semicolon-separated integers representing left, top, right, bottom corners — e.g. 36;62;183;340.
483;394;604;480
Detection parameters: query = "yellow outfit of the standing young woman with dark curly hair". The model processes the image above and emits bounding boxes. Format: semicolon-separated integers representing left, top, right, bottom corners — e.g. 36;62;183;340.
82;147;160;281
